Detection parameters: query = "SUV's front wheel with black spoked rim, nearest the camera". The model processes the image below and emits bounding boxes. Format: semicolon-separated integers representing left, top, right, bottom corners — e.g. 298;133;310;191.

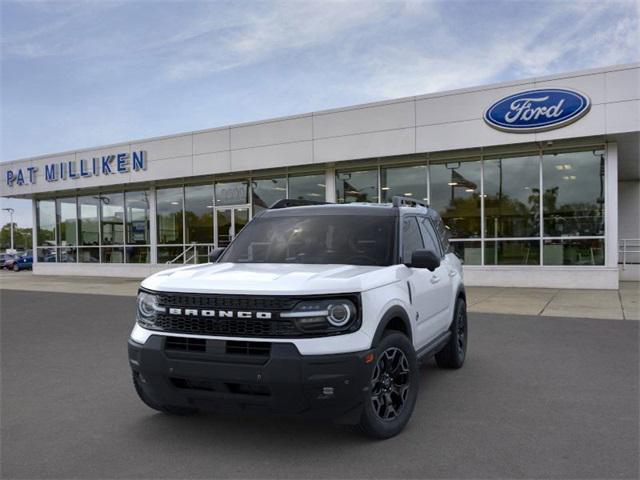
358;330;419;439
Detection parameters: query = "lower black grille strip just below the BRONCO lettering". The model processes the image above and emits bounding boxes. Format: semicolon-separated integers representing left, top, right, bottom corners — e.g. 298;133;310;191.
155;314;302;337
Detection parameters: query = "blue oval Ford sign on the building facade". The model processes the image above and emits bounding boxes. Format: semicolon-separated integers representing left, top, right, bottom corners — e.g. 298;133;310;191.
484;88;591;133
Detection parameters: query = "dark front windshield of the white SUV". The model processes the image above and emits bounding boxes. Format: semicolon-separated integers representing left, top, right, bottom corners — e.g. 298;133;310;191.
220;215;396;266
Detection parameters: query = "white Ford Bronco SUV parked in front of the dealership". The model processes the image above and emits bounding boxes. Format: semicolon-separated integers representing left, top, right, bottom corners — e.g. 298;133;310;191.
129;197;467;438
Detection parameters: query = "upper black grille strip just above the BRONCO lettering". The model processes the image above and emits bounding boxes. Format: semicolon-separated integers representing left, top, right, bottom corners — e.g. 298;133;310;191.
158;293;299;311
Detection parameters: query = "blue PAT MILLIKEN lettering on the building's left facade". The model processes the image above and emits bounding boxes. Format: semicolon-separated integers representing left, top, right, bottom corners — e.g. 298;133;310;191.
4;150;147;187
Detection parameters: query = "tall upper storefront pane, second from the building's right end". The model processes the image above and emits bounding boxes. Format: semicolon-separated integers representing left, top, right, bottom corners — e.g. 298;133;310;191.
484;155;540;238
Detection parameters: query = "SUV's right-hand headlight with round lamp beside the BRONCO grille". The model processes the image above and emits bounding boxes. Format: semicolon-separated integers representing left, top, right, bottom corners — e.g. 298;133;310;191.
280;298;358;333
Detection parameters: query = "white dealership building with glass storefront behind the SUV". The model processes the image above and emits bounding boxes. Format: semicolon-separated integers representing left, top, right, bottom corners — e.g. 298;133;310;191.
0;64;640;289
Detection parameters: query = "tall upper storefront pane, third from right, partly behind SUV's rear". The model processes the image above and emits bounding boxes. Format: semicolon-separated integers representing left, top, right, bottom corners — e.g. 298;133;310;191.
429;160;481;238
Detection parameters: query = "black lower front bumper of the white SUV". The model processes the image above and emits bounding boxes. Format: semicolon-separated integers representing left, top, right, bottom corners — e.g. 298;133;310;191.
129;335;373;423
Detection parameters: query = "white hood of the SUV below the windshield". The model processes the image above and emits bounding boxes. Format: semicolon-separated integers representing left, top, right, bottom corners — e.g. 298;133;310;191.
142;263;401;295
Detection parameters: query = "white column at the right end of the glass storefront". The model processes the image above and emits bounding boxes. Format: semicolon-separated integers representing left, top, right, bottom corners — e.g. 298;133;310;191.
604;142;618;267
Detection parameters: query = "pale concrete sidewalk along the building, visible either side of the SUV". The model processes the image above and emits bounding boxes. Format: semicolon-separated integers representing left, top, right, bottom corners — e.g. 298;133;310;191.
0;271;640;320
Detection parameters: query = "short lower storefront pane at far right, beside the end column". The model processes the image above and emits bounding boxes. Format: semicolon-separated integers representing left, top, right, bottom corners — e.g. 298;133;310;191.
542;238;604;265
